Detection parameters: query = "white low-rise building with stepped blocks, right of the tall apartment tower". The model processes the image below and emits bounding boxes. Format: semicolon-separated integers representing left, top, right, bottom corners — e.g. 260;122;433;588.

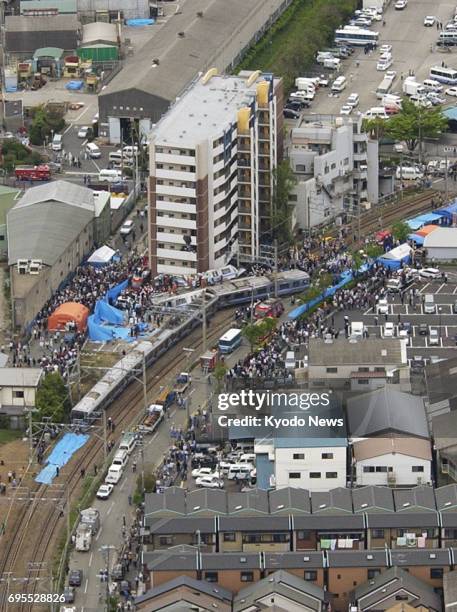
288;116;378;230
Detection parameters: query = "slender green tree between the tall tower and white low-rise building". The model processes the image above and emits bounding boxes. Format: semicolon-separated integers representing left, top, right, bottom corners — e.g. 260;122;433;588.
271;159;296;243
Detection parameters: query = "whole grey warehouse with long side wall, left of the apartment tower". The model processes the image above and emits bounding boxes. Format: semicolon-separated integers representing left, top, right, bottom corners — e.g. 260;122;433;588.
7;181;95;328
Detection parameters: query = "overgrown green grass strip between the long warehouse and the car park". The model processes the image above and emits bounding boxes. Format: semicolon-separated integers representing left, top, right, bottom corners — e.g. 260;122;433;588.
235;0;357;91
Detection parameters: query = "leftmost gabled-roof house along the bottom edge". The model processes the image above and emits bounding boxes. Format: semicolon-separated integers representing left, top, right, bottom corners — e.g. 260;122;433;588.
135;576;232;612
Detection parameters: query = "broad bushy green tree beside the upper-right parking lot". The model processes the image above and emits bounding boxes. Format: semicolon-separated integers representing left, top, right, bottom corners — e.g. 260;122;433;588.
386;98;448;153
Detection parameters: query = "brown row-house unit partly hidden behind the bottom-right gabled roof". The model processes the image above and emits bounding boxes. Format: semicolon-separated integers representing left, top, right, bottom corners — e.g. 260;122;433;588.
389;548;453;590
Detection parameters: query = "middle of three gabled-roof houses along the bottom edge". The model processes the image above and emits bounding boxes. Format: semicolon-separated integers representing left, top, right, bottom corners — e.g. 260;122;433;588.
233;570;329;612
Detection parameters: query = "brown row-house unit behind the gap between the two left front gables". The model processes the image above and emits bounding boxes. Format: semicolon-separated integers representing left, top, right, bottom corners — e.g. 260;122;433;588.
201;552;262;593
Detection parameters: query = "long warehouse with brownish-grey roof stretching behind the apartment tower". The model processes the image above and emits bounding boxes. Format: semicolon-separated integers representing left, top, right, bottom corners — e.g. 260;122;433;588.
99;0;291;143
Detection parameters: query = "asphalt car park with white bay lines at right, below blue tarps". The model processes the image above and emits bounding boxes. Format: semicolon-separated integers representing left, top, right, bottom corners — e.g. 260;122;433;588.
335;269;457;361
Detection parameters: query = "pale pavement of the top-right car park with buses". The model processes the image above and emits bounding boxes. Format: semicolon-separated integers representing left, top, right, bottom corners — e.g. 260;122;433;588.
291;0;457;117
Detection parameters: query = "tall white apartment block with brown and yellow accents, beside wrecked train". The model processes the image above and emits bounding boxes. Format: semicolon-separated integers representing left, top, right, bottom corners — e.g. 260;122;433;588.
149;69;282;275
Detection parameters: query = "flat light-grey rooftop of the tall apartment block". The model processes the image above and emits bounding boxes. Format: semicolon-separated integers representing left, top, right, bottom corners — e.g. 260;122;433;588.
151;70;271;148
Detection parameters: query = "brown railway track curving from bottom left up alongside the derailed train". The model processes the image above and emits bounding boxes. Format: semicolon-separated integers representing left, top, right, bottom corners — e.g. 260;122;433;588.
0;309;233;612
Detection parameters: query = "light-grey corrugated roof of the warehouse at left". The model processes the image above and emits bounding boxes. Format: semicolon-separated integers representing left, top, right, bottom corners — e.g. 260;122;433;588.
7;181;94;266
